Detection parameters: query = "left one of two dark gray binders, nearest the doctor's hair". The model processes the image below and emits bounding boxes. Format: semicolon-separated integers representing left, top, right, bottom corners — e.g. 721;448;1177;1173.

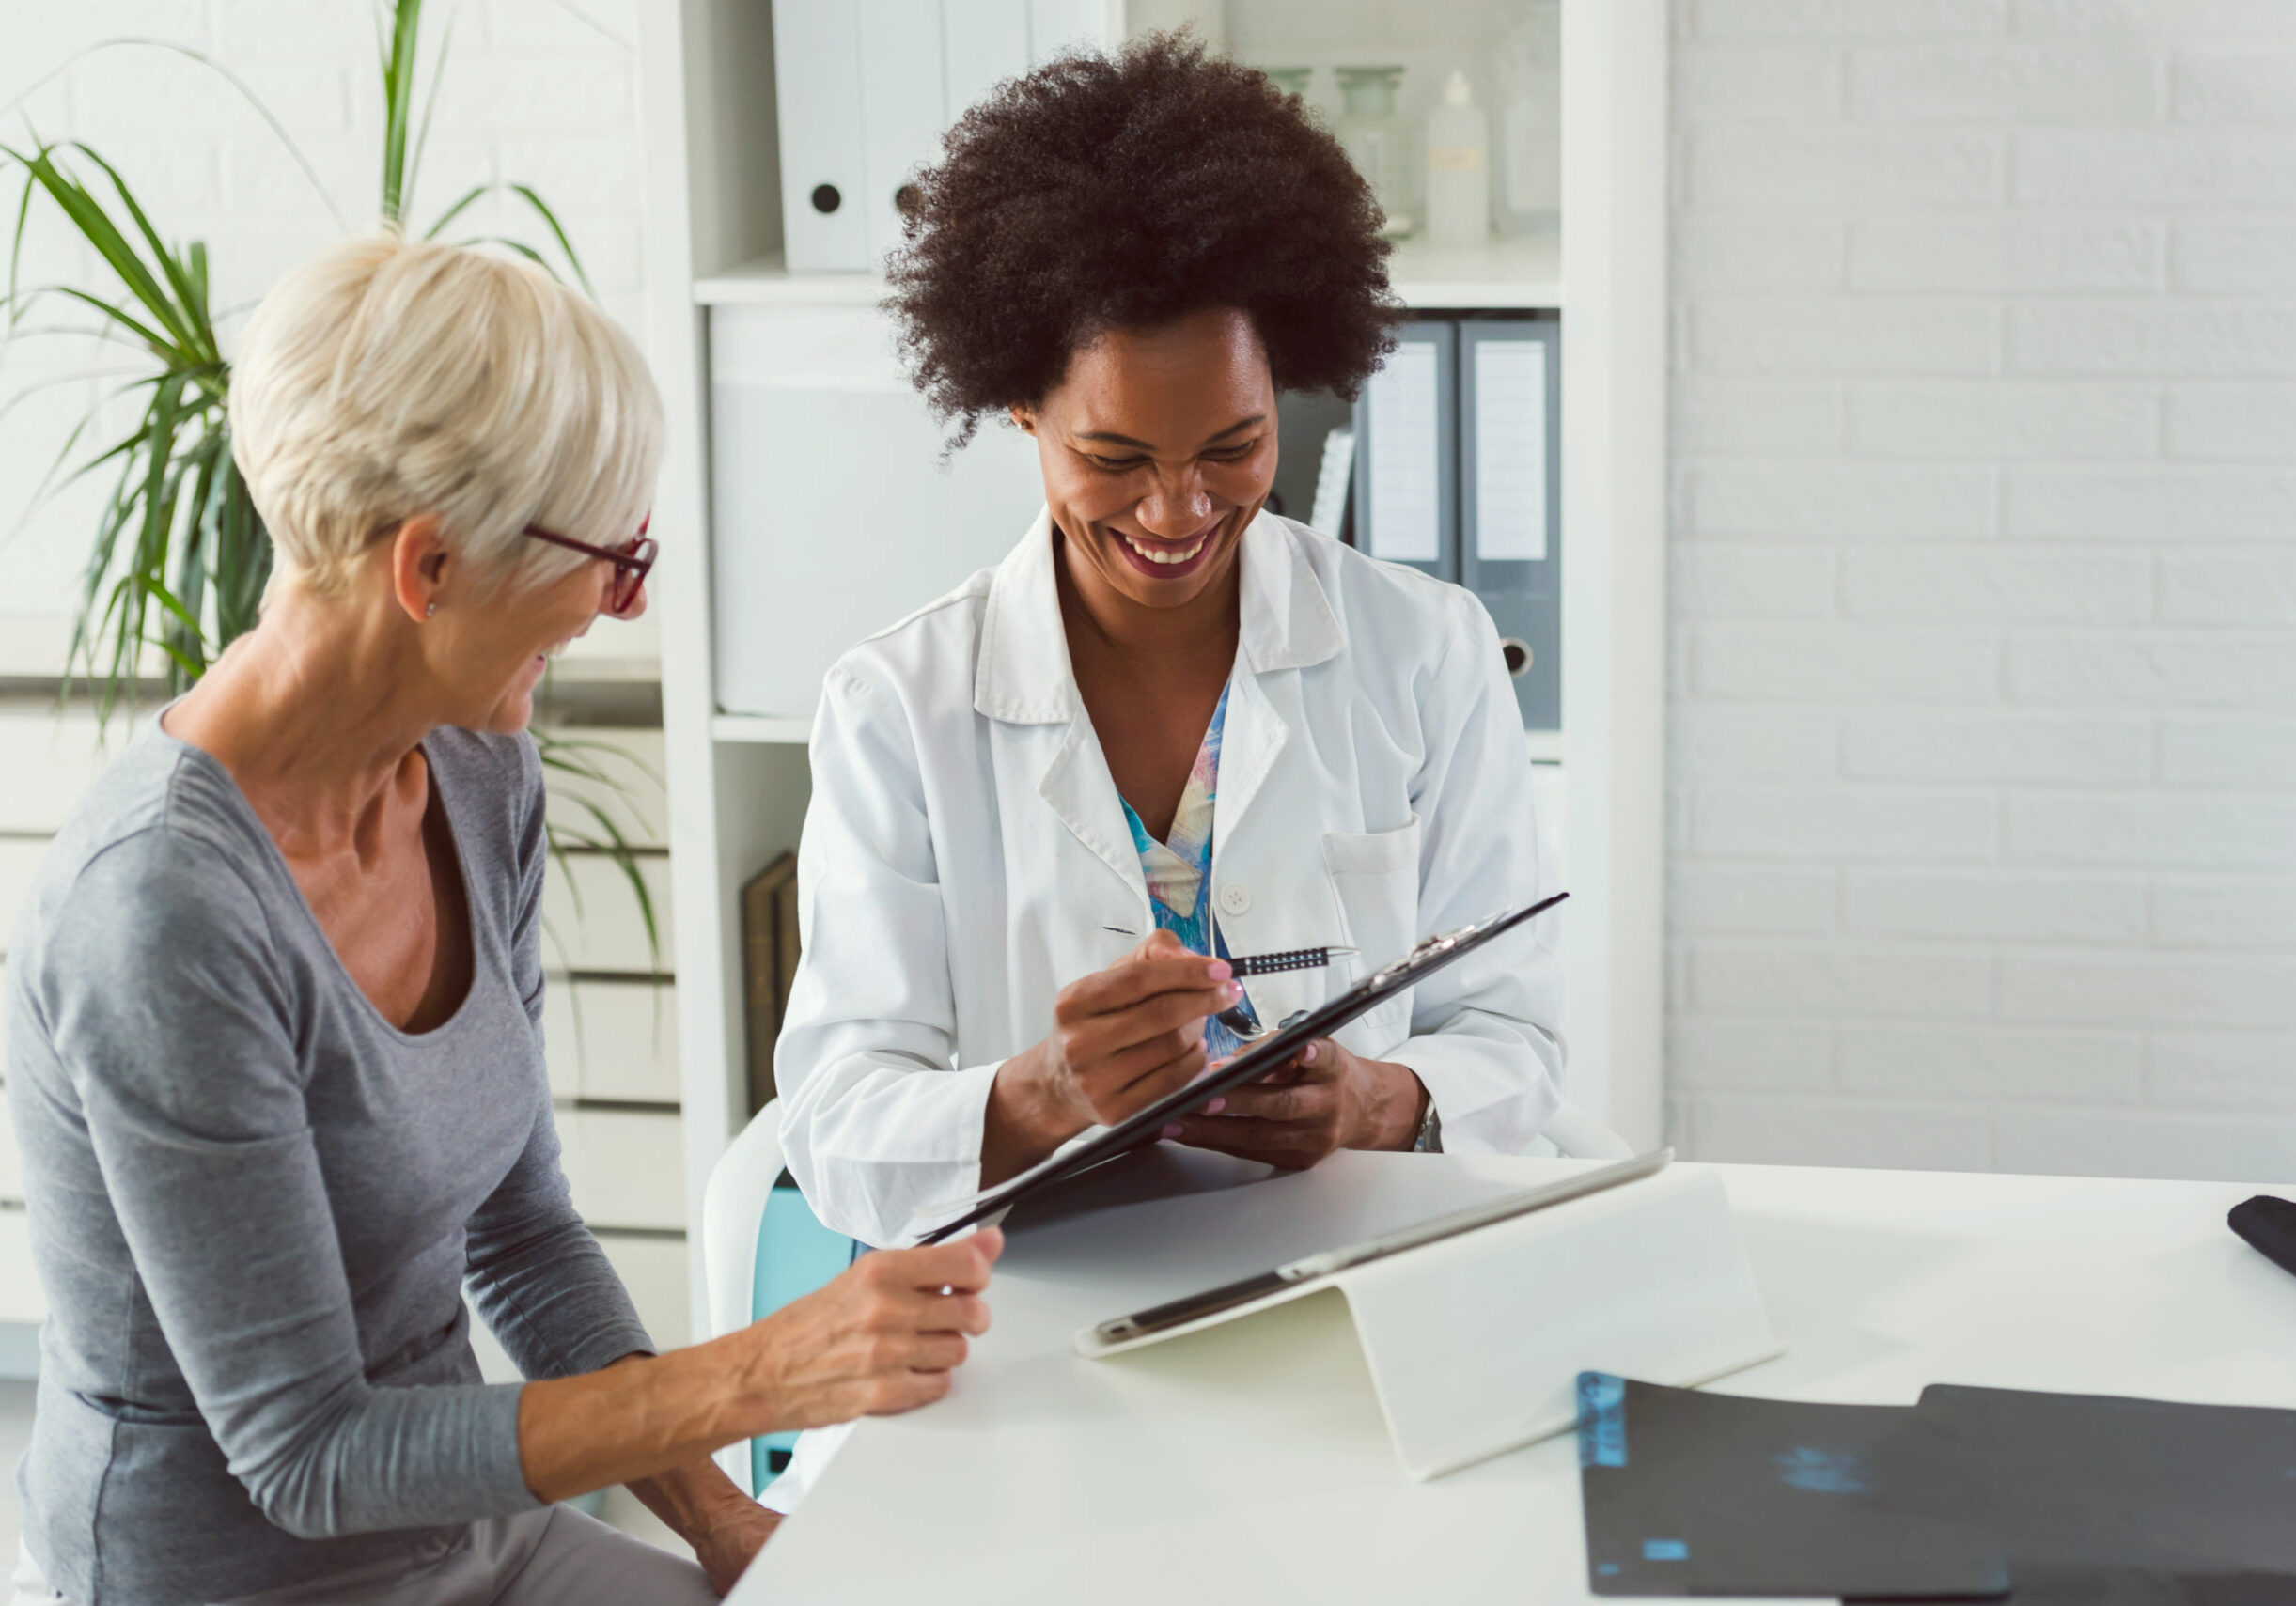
1354;319;1458;581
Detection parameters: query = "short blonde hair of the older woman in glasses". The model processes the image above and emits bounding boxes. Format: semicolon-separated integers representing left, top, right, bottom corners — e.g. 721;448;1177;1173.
232;234;662;592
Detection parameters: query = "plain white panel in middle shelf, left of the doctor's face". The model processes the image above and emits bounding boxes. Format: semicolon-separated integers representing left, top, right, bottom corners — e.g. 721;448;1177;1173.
710;305;1045;721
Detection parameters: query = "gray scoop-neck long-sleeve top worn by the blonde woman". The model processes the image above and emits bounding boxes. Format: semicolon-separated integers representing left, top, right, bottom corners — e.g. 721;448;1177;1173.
7;723;649;1606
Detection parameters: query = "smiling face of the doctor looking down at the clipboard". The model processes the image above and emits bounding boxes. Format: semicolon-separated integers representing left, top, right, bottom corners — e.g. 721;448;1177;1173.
1012;307;1276;613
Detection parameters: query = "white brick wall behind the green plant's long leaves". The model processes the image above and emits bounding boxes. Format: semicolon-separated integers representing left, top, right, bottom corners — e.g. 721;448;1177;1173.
0;0;645;677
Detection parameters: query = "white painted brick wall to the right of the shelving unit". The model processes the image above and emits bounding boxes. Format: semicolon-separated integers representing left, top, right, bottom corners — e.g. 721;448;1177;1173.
1669;0;2296;1181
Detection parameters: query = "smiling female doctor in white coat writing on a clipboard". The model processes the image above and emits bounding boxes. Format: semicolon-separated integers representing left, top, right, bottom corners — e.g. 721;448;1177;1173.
778;37;1561;1243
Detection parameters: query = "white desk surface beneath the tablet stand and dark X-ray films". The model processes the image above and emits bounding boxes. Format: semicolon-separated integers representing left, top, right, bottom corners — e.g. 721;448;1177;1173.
732;1149;2296;1606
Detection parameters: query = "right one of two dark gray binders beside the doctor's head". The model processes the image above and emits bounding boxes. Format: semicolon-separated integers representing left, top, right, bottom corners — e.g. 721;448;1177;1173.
1458;319;1564;729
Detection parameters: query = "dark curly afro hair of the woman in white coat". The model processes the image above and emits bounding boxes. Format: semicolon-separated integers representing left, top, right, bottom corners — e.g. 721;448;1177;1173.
886;35;1400;445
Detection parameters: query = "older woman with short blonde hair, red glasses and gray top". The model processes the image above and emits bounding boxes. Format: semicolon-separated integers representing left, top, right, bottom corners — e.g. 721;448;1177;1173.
7;239;996;1606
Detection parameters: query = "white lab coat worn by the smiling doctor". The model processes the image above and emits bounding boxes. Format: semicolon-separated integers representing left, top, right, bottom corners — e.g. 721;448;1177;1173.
773;514;1561;1246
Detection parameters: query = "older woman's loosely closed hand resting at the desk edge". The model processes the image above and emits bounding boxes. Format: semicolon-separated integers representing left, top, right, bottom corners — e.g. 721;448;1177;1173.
744;1227;1004;1431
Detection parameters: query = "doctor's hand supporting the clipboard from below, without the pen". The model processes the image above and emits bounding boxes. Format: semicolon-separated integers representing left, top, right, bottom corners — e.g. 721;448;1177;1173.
1164;1037;1426;1170
